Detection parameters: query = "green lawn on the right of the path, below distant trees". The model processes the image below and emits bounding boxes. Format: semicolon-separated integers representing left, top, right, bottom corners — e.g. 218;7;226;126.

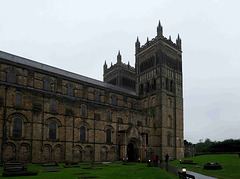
169;154;240;179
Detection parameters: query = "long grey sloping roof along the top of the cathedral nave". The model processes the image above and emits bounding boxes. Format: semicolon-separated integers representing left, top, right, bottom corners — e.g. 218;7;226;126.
0;51;136;96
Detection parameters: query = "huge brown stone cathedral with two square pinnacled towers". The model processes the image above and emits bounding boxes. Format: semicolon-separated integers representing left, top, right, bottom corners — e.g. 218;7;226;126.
0;22;184;163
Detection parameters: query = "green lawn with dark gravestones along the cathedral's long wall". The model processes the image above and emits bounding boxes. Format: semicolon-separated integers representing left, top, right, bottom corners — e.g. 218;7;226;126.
0;163;177;179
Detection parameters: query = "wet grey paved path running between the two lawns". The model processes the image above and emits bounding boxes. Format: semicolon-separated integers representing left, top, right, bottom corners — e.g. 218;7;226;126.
160;163;216;179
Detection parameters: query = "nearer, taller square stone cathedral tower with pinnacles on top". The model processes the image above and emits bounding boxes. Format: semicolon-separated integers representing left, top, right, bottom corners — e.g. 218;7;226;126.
135;21;184;158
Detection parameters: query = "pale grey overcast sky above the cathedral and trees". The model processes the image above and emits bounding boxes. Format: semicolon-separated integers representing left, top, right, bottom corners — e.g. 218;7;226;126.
0;0;240;143
